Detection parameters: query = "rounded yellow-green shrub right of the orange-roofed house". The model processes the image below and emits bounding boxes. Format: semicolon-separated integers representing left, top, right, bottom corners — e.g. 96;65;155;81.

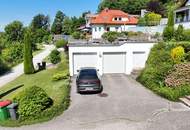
145;12;162;26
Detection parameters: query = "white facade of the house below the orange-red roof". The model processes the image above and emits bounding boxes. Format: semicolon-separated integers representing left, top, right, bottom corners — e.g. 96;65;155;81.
92;24;136;39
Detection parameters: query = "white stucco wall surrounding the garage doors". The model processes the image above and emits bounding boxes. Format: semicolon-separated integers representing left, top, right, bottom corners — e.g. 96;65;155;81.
69;43;155;76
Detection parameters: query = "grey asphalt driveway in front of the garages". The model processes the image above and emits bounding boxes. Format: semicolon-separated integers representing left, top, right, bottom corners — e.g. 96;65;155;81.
0;74;190;130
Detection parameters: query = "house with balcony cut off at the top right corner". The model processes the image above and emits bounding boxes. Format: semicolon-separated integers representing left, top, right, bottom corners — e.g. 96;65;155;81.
174;0;190;28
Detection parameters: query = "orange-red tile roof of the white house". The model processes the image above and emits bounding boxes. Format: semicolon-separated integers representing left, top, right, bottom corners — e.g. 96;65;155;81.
91;9;138;25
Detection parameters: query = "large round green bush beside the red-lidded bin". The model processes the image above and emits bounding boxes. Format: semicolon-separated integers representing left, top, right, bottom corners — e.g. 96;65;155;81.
14;86;53;120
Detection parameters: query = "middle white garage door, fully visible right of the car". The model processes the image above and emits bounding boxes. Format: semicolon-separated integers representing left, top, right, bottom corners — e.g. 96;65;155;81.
103;52;126;73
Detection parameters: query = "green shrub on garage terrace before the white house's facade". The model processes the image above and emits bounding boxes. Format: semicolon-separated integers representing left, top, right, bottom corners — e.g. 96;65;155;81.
102;32;118;43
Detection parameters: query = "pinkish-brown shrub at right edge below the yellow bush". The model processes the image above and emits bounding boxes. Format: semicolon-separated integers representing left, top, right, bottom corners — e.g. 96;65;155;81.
165;63;190;87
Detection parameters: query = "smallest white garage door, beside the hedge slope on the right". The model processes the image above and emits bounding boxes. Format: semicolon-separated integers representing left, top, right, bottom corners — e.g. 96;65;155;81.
133;52;147;69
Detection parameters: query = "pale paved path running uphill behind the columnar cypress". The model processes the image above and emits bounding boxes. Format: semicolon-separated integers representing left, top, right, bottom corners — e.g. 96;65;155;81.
0;45;54;87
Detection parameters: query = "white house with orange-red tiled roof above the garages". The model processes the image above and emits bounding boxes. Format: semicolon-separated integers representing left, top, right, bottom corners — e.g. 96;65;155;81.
90;9;138;39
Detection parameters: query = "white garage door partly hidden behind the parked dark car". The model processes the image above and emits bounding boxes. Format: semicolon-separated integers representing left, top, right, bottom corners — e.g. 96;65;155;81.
73;53;98;74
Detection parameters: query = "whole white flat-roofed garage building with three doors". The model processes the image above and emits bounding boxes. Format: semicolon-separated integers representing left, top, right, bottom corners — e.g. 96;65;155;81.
69;42;155;76
